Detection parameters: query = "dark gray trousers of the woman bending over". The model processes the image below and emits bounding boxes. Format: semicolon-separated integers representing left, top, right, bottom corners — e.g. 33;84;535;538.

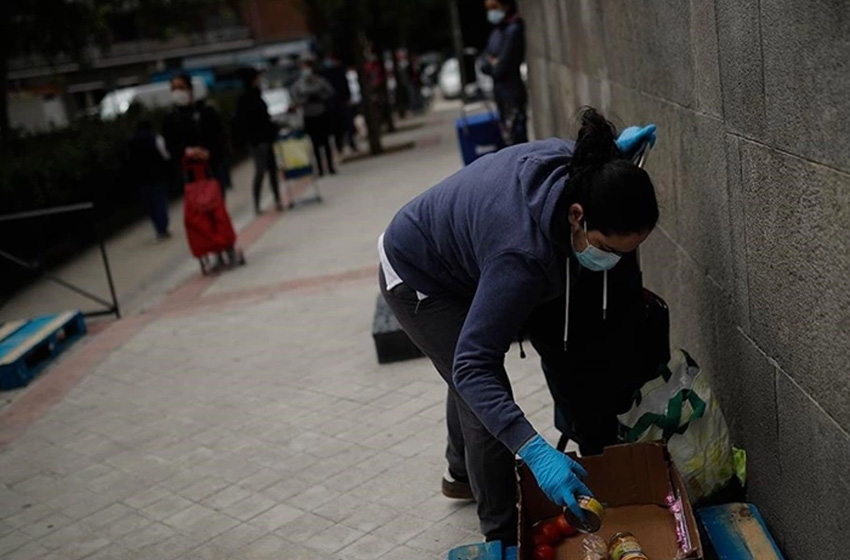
378;271;517;545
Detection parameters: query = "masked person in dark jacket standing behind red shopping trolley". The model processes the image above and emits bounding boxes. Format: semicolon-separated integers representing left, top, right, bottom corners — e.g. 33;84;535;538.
162;74;230;194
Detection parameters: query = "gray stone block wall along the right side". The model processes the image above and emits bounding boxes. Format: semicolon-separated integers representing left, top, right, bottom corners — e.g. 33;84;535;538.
520;0;850;558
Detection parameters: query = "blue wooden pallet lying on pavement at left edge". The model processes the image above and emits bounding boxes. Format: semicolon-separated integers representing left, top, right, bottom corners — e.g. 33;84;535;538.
0;311;86;390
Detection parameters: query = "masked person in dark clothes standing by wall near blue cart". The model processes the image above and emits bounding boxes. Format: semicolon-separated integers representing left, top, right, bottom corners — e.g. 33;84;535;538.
481;0;528;146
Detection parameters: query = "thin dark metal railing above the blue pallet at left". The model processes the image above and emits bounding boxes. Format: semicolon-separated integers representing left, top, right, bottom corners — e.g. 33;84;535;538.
0;202;121;319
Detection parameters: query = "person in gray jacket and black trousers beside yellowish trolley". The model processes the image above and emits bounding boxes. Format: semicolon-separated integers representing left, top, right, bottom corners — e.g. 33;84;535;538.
292;55;336;177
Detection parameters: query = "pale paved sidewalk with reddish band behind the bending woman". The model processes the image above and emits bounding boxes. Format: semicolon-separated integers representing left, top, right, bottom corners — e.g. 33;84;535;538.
0;101;568;560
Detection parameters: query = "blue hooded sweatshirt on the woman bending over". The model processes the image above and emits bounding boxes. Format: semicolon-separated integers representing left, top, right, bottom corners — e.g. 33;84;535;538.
384;138;574;453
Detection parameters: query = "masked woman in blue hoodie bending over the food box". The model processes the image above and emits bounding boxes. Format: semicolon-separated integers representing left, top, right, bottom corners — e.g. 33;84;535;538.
378;108;658;545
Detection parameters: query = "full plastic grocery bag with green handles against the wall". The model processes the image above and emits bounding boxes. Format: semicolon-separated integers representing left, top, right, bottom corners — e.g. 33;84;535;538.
618;350;736;501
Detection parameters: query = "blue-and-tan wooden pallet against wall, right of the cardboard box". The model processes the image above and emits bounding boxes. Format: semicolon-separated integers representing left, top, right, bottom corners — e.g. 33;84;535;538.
697;503;782;560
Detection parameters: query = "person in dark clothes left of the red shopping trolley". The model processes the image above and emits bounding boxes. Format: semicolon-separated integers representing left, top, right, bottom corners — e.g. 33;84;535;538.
126;119;171;241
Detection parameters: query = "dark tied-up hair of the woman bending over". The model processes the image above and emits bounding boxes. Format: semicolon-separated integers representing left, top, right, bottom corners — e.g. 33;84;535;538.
560;107;658;235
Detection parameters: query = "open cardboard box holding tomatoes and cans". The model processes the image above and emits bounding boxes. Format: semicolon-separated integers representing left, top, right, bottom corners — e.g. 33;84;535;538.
517;443;703;560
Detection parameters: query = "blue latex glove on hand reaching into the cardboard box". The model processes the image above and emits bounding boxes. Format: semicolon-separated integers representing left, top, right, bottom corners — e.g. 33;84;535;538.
518;435;593;519
